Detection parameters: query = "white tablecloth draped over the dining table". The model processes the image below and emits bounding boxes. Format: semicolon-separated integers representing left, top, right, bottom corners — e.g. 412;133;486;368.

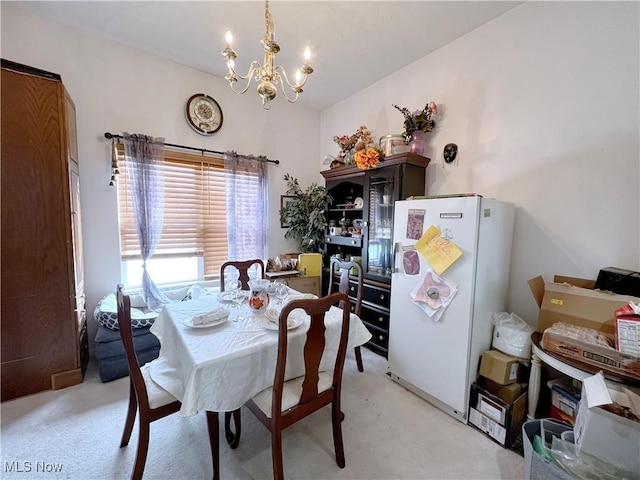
150;296;371;416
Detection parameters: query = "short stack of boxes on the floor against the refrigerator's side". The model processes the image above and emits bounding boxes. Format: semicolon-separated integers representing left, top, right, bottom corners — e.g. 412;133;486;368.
469;350;528;449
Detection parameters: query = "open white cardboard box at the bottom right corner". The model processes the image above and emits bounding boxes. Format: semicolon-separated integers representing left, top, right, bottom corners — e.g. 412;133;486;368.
574;386;640;474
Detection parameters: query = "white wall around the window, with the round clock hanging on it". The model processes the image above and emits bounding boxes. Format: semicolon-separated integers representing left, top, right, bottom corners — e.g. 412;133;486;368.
1;5;326;346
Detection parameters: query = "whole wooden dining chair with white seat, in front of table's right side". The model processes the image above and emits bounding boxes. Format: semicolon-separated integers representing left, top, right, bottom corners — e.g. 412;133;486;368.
246;293;350;480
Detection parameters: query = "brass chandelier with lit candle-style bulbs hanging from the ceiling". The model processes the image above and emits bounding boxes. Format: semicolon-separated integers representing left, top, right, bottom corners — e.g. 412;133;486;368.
222;0;313;110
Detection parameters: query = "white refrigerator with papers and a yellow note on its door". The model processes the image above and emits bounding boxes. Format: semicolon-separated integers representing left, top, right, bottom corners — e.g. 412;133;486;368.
388;194;515;423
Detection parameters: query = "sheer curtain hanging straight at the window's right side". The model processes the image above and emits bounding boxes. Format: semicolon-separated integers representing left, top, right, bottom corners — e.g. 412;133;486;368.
224;152;268;260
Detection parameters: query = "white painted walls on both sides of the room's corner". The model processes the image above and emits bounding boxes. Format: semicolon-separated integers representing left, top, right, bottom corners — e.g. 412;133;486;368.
1;2;640;344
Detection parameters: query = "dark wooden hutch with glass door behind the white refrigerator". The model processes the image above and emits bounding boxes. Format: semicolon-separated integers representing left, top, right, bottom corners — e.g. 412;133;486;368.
321;153;429;357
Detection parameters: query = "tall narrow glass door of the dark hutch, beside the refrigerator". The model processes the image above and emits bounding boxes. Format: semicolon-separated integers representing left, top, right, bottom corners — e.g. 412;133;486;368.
363;170;396;283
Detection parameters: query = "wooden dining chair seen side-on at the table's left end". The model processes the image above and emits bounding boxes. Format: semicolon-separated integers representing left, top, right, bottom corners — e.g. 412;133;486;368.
116;285;220;480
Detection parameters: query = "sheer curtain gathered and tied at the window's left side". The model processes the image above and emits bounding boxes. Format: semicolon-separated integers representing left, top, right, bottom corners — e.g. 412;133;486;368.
122;132;169;310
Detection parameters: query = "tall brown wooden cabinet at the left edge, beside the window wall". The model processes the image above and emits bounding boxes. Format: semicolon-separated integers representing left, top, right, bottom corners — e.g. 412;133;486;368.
0;59;89;401
